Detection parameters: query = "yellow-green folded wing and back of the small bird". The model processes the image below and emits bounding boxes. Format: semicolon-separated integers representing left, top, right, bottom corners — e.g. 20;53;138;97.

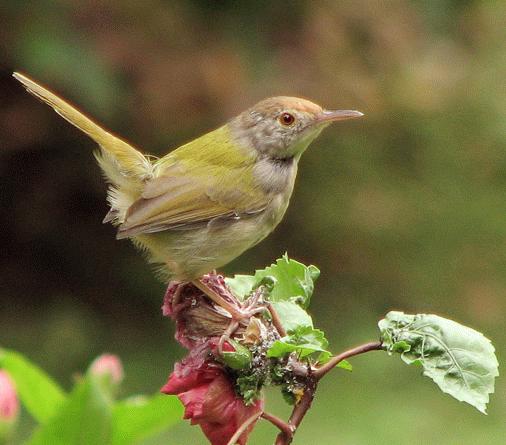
118;128;264;238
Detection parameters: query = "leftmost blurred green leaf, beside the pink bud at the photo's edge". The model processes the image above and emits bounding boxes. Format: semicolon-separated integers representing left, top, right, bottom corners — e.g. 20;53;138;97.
0;349;65;423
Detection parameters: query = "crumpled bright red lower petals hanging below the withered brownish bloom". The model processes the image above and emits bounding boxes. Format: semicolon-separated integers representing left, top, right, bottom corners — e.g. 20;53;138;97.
162;342;263;445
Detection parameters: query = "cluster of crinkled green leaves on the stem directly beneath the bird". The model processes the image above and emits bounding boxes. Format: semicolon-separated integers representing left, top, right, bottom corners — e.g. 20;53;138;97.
226;254;351;403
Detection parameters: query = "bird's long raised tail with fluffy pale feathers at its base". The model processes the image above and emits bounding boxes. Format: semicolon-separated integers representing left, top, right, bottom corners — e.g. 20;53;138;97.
13;73;152;224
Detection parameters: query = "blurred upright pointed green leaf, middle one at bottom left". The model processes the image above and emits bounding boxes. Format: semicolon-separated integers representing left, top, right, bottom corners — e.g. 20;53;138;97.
27;377;112;445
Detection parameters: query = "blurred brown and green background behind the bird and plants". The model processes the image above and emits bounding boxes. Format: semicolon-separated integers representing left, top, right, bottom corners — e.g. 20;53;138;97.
0;0;506;445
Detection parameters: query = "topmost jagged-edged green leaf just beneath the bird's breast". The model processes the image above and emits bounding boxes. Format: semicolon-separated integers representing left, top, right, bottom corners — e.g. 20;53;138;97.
226;254;320;308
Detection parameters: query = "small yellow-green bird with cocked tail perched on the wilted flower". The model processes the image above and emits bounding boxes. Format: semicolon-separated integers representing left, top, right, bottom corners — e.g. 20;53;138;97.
13;73;363;309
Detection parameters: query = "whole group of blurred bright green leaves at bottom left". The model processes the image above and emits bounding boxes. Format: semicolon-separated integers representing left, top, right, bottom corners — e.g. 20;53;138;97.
0;349;182;445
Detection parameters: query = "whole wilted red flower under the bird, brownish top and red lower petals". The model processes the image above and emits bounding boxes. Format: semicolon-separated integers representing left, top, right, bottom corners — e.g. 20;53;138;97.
162;274;263;445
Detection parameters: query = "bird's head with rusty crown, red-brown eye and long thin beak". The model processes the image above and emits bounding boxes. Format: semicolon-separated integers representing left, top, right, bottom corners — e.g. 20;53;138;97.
230;96;363;159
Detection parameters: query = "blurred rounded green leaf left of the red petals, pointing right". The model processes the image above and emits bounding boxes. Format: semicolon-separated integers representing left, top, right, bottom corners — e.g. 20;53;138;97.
111;394;183;445
